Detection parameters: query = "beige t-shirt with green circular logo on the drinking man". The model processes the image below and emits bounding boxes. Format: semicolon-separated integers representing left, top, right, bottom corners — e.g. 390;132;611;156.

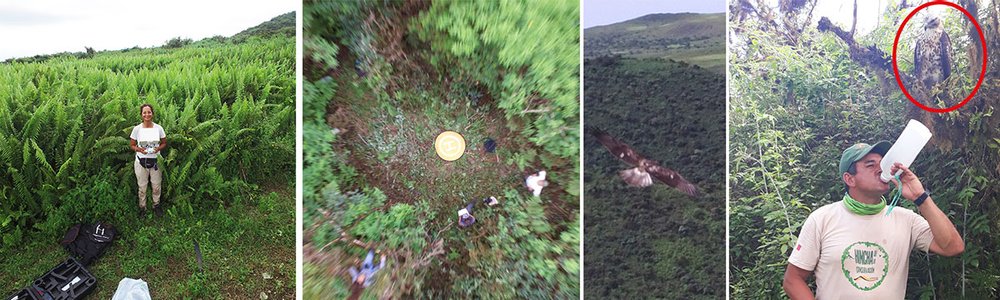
788;201;934;299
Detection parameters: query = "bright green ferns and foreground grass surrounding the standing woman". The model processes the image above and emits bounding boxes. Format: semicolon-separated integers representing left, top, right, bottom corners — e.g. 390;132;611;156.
0;13;295;298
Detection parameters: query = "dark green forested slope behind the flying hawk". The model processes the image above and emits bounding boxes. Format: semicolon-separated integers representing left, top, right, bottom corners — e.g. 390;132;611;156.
584;57;726;299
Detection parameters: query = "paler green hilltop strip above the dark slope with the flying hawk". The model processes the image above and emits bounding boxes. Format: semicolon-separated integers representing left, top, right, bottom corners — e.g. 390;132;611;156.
583;13;726;73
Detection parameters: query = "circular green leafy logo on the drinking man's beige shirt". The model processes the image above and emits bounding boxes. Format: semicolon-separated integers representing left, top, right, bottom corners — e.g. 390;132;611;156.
840;242;889;291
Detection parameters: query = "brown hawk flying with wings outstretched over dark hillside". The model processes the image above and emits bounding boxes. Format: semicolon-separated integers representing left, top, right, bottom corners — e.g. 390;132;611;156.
590;128;698;196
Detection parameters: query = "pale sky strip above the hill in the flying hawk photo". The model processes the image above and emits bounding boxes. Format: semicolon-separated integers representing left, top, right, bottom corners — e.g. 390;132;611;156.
583;0;727;28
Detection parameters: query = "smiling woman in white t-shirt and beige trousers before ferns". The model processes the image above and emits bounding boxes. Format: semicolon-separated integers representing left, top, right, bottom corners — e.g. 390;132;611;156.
130;104;167;217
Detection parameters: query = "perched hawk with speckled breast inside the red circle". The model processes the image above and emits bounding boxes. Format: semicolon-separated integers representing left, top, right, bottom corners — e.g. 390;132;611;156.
913;17;951;88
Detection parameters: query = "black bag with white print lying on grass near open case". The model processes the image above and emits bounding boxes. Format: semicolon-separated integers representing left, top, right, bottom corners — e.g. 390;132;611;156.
59;222;118;266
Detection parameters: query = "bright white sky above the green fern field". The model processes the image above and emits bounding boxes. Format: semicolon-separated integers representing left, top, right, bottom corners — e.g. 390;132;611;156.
0;0;294;60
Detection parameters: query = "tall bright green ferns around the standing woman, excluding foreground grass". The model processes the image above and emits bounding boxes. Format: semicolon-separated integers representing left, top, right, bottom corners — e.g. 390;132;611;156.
0;37;295;243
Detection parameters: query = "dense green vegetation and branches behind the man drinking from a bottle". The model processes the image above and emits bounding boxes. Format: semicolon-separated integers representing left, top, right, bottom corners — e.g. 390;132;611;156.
729;1;1000;299
